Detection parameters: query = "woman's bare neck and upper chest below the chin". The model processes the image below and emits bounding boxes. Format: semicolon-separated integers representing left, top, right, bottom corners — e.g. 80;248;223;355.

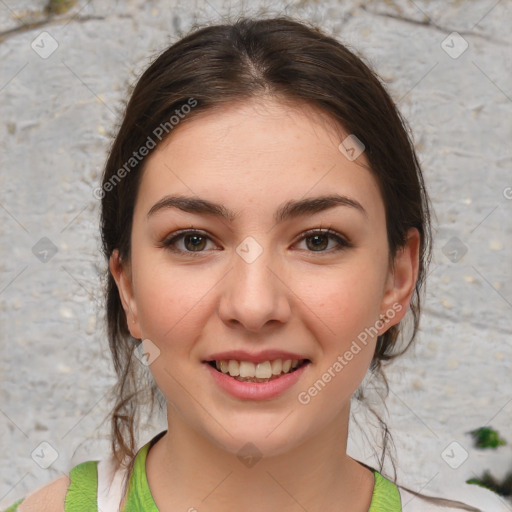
146;407;373;512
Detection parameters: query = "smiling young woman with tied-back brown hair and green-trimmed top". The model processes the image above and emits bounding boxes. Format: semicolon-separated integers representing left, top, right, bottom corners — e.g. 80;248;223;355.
7;18;484;512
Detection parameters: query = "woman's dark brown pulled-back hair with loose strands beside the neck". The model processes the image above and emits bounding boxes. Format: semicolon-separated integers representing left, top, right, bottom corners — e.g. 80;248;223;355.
101;12;438;496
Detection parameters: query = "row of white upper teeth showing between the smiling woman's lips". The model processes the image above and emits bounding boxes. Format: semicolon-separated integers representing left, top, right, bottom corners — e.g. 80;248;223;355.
205;359;311;383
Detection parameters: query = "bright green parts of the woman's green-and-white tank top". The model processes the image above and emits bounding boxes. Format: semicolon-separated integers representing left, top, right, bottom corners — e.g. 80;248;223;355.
5;436;402;512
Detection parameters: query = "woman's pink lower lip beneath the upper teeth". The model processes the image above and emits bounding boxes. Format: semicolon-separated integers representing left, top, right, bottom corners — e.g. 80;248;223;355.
203;363;309;400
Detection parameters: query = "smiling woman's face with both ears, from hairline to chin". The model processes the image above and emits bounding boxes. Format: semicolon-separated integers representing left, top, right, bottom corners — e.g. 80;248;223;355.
111;100;417;455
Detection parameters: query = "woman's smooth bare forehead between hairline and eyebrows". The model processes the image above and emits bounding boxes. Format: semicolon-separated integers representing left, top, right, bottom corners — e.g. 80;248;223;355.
137;99;384;222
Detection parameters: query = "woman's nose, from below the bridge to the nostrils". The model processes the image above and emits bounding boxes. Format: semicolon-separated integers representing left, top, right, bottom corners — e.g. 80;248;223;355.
219;240;293;332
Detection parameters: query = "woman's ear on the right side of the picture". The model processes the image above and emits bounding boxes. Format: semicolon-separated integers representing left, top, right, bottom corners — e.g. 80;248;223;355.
378;228;420;335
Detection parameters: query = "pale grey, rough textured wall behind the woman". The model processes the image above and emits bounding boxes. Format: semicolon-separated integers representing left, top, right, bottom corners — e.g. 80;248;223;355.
0;0;512;510
